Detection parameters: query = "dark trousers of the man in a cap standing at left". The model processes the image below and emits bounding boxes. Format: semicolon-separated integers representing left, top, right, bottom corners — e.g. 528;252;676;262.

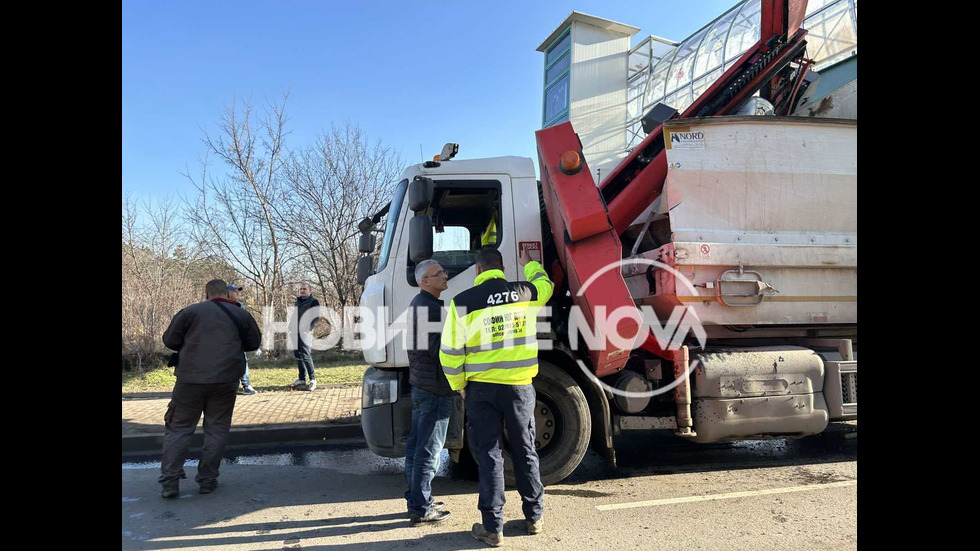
158;380;238;485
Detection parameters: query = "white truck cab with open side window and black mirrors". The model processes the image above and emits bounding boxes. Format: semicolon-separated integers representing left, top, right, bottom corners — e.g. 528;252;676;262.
361;157;542;457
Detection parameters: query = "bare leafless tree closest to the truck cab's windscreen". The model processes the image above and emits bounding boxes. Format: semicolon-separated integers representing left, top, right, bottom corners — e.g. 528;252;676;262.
280;121;403;336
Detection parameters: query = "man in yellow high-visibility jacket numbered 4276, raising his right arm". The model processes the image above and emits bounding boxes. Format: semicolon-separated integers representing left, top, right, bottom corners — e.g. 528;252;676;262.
439;247;554;545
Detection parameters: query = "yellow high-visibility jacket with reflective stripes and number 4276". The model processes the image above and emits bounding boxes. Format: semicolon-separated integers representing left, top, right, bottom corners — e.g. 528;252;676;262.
439;261;555;390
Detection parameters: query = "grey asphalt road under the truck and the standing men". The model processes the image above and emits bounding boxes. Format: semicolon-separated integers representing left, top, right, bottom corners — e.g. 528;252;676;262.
122;425;857;551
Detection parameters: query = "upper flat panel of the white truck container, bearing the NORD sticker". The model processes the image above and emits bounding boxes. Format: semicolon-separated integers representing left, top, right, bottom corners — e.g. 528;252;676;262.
664;117;857;243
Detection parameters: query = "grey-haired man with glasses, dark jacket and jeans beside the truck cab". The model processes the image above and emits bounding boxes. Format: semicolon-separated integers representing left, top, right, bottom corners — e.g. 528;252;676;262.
405;260;454;524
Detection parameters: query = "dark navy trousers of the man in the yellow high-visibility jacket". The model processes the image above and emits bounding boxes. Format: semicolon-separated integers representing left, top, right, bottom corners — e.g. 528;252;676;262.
466;382;544;532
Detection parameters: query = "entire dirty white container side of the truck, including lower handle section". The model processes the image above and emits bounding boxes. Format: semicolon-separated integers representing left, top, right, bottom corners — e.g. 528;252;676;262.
624;117;857;326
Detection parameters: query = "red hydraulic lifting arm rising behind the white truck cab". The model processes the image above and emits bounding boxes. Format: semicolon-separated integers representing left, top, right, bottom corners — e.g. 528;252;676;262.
535;0;806;377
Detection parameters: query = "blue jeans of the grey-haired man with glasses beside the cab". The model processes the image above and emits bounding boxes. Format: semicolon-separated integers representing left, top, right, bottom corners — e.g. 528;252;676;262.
405;387;453;517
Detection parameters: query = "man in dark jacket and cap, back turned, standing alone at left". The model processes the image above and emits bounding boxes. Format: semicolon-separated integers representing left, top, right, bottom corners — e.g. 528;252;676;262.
158;279;262;498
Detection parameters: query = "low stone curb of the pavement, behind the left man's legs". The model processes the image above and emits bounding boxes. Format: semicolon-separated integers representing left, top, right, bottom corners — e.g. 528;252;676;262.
122;423;364;455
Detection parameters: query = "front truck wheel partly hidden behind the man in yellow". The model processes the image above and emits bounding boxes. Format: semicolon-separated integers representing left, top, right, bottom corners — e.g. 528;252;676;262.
504;360;592;486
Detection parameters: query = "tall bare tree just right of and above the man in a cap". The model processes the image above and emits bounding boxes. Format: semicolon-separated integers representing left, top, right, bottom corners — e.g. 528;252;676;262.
184;94;290;311
